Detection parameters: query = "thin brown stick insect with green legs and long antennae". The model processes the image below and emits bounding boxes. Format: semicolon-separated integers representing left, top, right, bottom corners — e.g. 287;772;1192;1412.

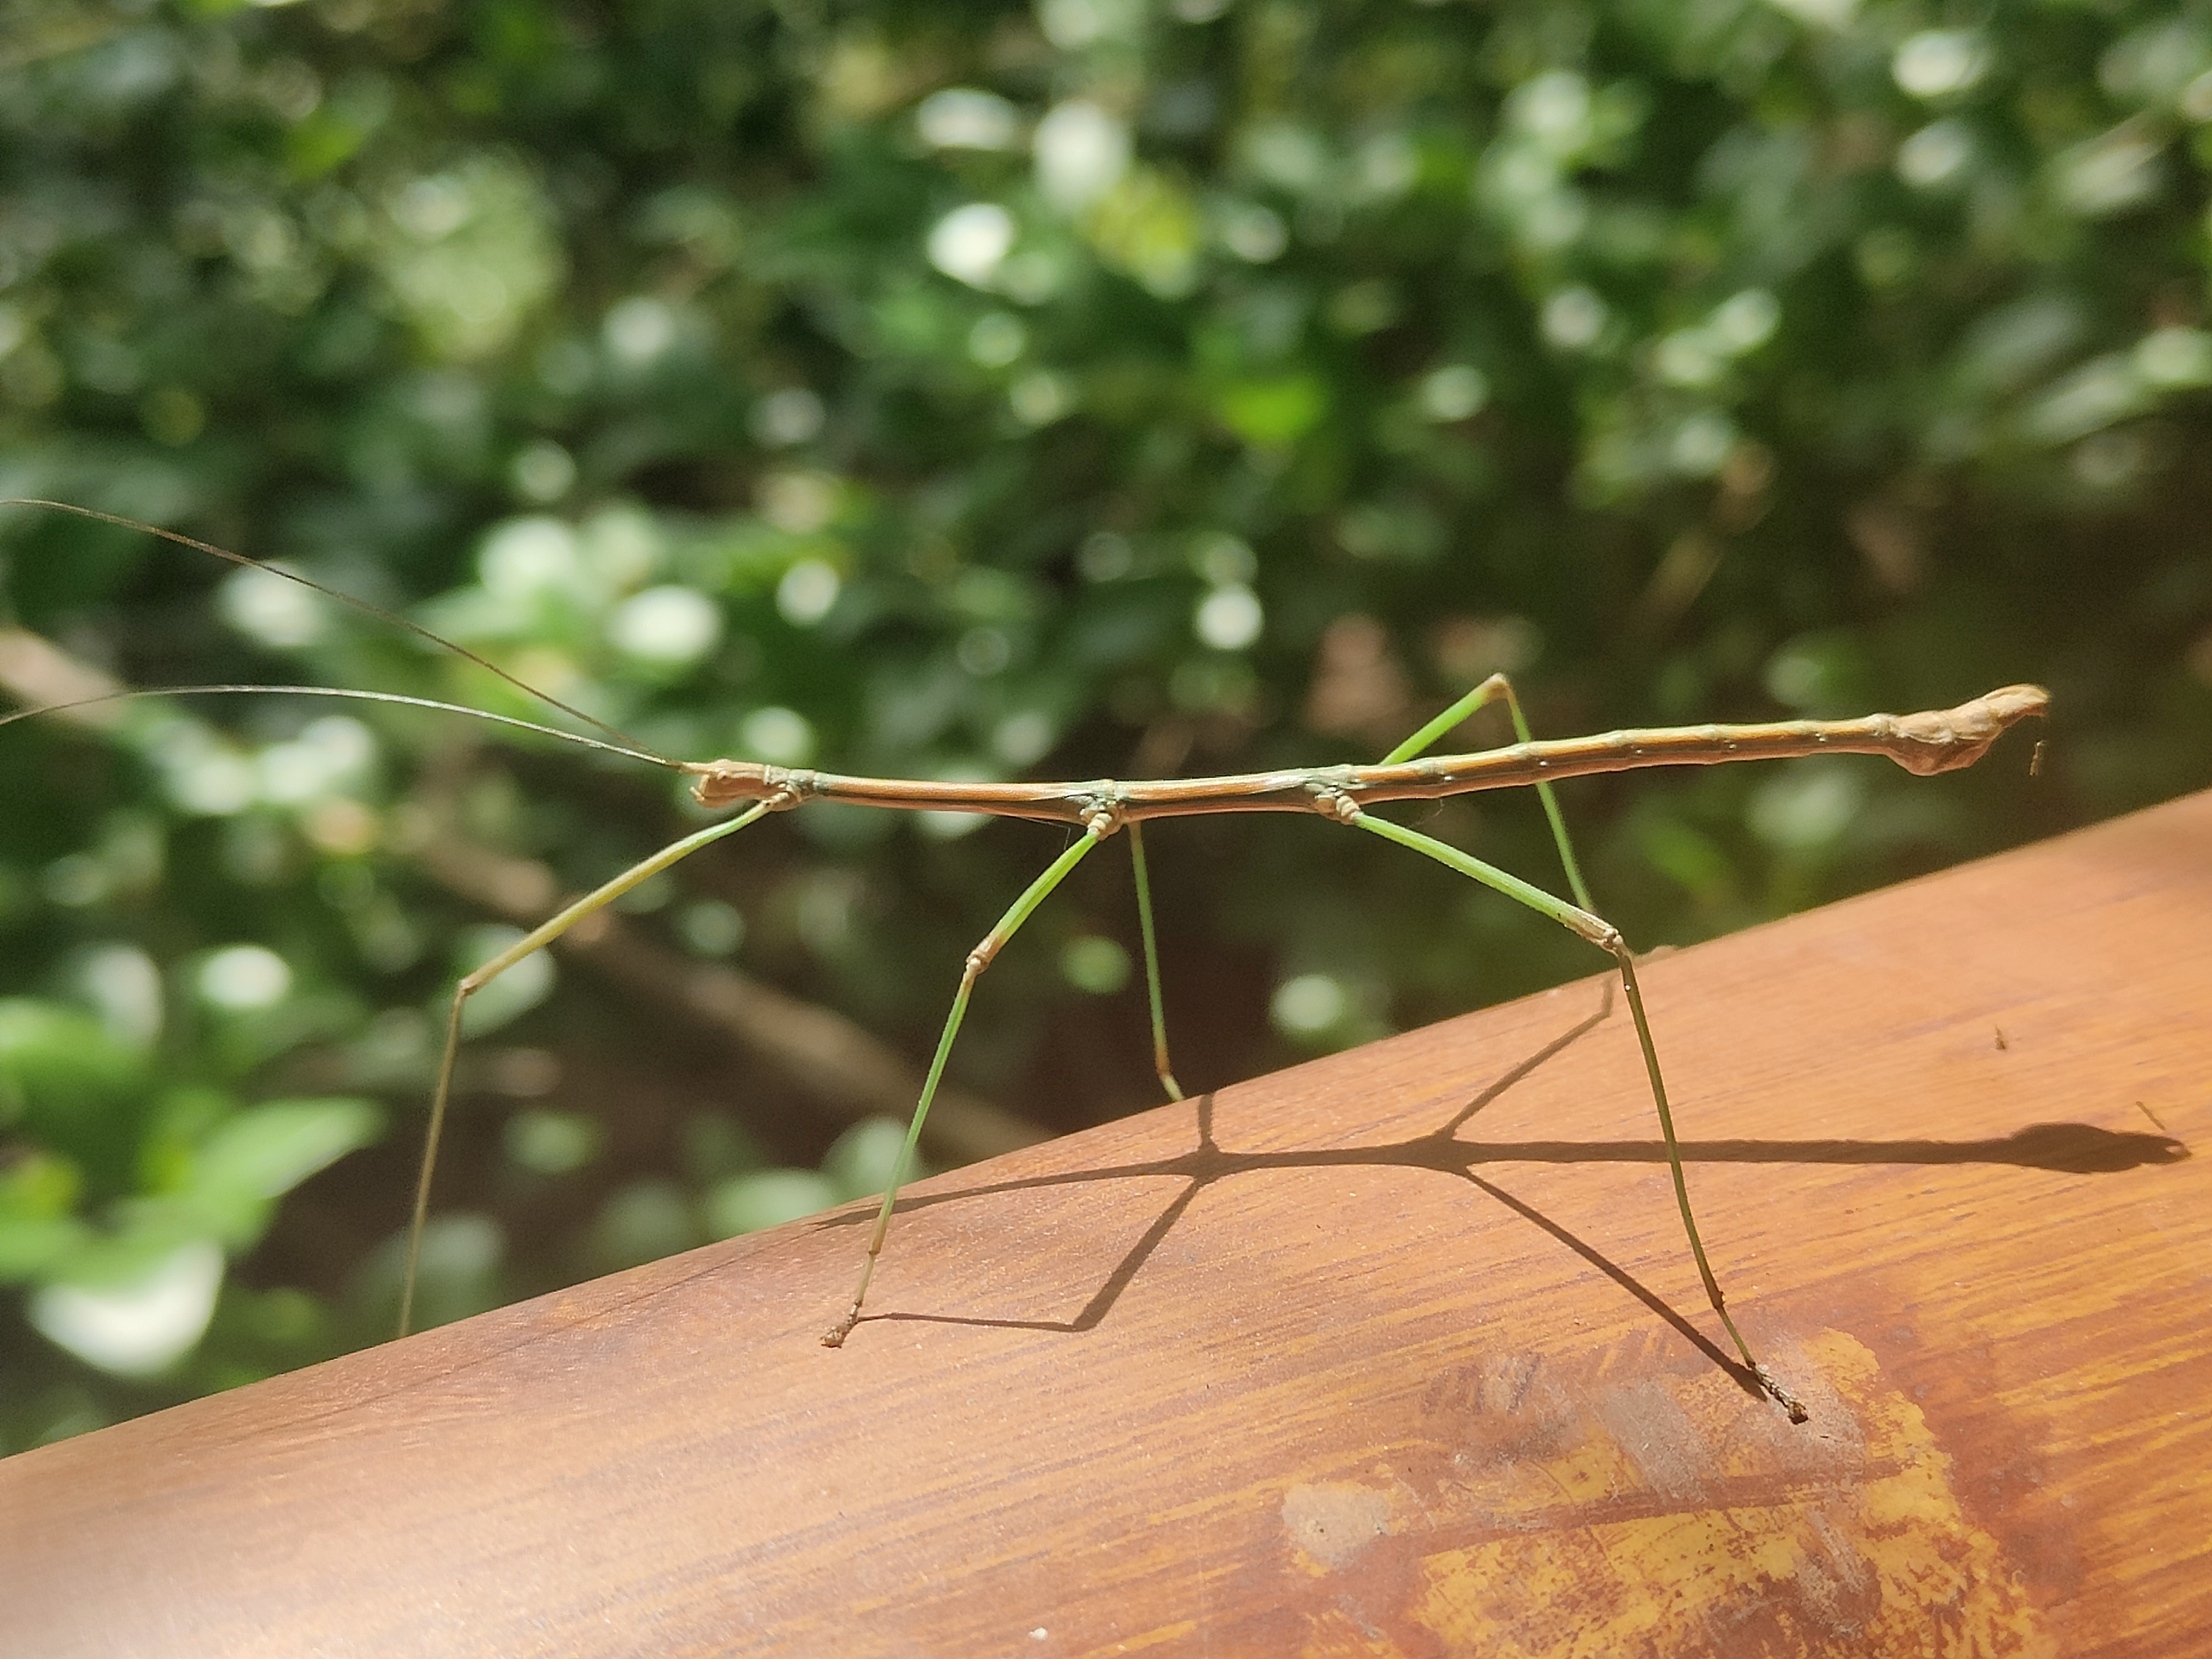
0;502;2048;1422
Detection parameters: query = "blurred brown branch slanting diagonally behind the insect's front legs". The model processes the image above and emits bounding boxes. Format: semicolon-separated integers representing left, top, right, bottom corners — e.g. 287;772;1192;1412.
416;799;1051;1163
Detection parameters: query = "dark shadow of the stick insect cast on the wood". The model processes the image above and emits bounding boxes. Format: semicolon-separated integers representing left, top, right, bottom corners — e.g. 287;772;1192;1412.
816;984;2190;1396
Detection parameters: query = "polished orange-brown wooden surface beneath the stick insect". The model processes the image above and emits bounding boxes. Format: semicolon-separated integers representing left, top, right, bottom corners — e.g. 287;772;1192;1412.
0;797;2212;1659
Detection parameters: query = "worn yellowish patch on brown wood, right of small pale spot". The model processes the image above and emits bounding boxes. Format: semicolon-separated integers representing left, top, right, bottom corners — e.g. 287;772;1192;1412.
1400;1332;2055;1659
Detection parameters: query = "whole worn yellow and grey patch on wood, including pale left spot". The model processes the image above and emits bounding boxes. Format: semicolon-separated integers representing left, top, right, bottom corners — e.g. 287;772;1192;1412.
1283;1332;2057;1659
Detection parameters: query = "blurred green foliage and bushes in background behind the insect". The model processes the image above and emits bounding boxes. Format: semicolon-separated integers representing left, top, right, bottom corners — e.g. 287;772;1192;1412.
0;0;2212;1447
